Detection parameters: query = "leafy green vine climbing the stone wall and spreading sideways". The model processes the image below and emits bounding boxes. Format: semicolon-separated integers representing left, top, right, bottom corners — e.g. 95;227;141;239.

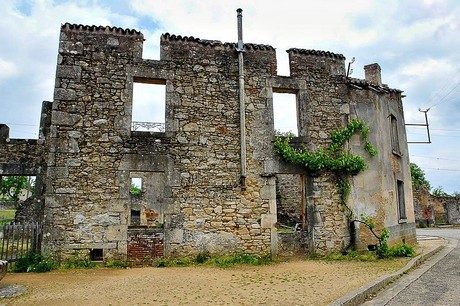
274;119;388;252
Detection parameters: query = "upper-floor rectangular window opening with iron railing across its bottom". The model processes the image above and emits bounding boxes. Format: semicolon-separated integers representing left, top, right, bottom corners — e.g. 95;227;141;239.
131;78;166;132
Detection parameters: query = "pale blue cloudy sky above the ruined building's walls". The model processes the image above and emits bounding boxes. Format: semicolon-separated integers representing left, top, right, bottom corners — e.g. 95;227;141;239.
0;0;460;193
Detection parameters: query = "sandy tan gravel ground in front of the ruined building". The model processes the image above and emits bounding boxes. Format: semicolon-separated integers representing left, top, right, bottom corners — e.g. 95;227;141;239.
0;241;444;305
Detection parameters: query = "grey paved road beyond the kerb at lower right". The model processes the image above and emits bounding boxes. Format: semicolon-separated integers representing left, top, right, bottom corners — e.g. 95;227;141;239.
365;228;460;306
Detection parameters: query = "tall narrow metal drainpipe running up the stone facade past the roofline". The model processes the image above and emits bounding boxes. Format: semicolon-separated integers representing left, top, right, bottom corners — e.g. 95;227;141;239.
236;8;246;190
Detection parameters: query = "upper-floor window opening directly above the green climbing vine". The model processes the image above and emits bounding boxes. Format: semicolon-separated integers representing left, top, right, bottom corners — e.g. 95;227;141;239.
273;92;299;136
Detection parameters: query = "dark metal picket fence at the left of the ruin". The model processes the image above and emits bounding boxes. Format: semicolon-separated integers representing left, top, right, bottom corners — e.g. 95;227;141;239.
0;223;42;262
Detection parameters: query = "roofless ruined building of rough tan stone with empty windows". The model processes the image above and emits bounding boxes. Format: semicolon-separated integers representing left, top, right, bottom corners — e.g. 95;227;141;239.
0;24;415;262
